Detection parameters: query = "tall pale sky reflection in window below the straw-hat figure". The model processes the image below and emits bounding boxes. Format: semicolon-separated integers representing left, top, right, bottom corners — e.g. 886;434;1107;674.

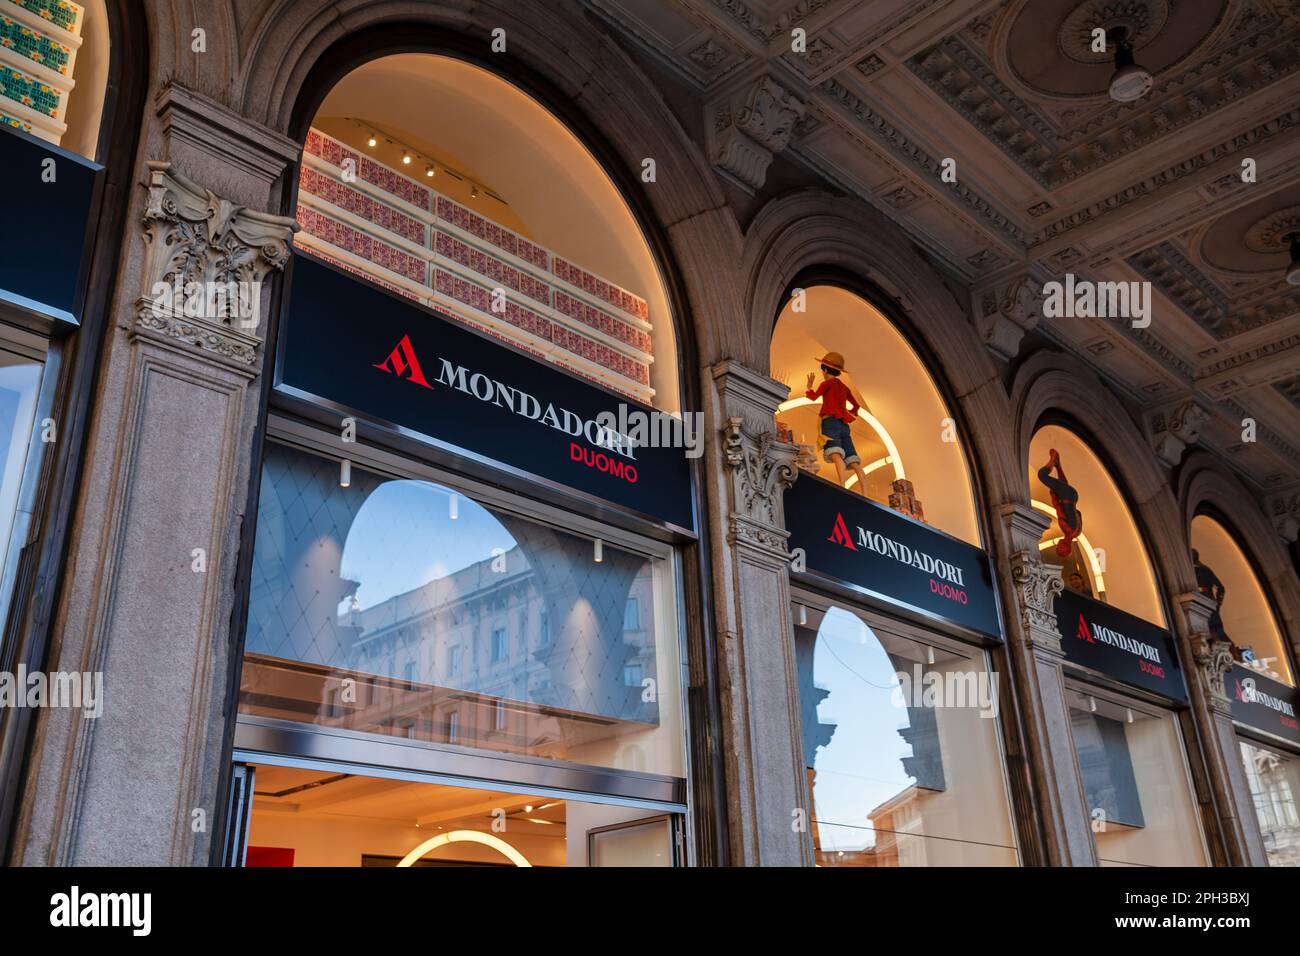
813;607;913;851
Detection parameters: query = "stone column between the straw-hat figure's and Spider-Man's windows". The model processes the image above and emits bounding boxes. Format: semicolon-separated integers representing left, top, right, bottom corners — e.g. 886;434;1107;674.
1000;505;1097;866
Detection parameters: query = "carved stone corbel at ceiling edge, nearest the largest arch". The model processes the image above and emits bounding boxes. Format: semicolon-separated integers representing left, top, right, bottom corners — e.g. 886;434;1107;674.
707;74;806;193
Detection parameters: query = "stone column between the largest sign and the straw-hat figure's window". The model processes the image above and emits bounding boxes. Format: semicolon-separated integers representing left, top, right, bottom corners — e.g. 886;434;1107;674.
710;360;813;866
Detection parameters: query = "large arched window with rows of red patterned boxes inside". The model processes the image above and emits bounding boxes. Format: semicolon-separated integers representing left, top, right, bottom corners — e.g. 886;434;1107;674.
296;53;680;412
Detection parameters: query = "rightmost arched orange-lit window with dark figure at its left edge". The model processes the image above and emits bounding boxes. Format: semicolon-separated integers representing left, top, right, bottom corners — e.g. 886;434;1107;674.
1191;514;1295;687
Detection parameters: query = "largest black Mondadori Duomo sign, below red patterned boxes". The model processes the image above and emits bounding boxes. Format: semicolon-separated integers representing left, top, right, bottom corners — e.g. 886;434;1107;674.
276;252;694;532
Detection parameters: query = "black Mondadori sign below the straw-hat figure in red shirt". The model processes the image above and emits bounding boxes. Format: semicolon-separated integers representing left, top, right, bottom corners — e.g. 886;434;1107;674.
785;475;1001;639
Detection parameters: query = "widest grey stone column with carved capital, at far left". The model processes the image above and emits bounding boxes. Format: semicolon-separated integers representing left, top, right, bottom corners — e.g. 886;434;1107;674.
14;86;298;865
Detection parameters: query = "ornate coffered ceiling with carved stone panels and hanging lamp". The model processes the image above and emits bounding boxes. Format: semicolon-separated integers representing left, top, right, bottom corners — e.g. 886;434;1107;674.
586;0;1300;515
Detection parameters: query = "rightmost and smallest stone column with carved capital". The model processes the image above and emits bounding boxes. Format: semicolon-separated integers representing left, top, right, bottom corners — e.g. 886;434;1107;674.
1178;591;1268;866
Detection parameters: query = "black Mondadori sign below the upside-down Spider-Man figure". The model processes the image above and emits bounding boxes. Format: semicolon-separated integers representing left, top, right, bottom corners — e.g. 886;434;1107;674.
1056;589;1187;701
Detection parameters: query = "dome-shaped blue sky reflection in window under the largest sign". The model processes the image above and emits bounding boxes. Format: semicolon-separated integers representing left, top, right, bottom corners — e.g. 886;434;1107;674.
341;481;515;613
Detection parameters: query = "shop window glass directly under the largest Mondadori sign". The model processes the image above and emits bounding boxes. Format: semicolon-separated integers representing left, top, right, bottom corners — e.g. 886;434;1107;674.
241;444;684;777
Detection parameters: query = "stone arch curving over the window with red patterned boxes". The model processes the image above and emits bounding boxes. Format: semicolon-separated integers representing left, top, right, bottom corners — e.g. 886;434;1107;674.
160;0;742;369
